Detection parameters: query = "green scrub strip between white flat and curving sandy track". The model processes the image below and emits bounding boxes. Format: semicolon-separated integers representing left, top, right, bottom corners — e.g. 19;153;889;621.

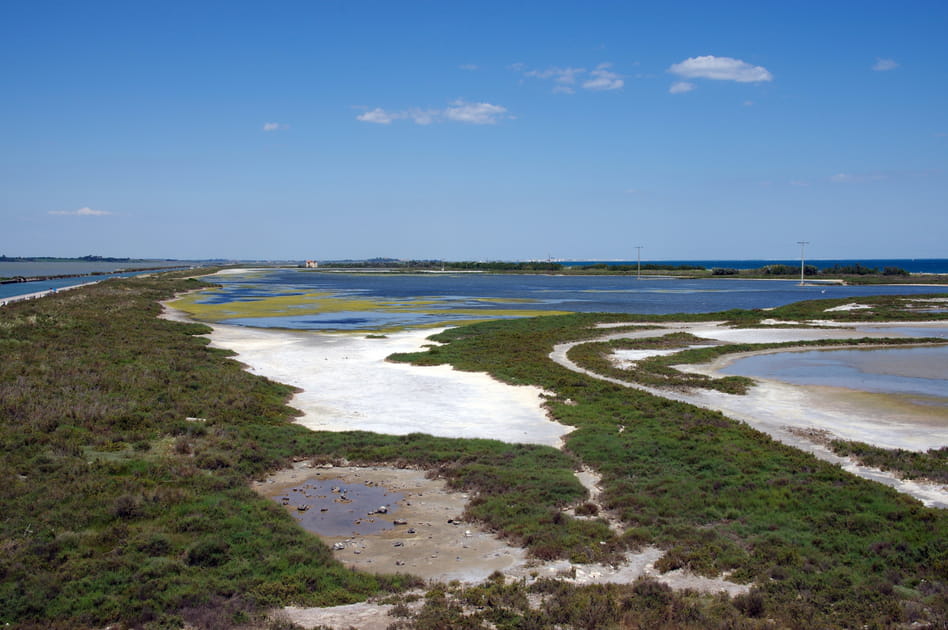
397;314;948;628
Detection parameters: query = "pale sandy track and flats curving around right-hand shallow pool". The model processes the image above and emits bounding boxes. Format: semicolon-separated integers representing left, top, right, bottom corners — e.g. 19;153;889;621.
550;322;948;508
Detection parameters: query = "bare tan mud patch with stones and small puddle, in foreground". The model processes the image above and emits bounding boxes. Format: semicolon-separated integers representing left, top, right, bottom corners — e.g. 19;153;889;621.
254;462;525;582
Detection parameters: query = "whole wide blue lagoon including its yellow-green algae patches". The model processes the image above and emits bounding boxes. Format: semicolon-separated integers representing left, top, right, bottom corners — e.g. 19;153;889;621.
188;269;939;331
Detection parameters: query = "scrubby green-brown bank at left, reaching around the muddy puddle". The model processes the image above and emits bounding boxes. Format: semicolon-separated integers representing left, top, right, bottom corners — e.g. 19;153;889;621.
0;277;615;628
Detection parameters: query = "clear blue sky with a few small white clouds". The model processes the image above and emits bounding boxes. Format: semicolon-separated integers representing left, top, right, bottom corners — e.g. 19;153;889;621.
0;0;948;260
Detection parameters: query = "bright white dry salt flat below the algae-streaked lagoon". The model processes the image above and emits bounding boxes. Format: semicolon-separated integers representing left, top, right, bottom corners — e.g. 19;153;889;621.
199;325;570;446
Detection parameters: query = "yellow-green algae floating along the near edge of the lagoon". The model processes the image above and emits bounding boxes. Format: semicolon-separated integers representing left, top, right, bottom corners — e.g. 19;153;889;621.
170;289;566;332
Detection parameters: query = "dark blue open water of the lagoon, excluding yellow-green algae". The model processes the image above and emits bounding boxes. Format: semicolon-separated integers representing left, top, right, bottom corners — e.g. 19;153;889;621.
203;269;948;330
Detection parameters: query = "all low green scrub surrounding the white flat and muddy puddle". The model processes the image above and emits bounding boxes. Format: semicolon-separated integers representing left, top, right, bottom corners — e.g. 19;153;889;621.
0;274;948;628
